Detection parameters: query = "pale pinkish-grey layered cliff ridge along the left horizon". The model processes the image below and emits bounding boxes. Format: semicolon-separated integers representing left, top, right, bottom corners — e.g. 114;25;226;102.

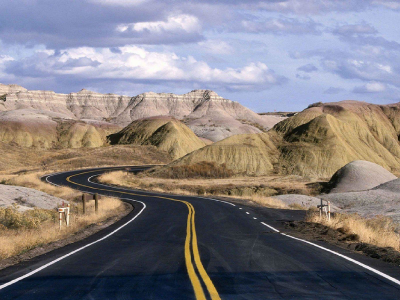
0;84;284;141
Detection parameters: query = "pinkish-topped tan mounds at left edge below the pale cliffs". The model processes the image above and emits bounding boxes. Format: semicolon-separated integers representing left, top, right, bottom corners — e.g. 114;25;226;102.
0;109;120;149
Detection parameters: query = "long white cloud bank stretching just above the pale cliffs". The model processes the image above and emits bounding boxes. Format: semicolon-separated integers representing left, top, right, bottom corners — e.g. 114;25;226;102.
10;46;286;89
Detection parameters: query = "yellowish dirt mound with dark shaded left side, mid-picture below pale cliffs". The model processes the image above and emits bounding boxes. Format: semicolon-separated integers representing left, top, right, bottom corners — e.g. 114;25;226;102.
109;116;206;159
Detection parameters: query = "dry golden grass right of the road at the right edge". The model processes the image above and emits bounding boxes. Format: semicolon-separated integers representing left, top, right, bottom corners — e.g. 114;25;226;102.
306;212;400;251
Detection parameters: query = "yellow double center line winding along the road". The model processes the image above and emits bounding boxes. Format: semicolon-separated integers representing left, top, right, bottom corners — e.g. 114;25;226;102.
67;170;221;300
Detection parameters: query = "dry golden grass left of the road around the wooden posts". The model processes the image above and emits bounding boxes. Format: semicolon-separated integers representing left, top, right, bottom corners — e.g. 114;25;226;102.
0;198;124;259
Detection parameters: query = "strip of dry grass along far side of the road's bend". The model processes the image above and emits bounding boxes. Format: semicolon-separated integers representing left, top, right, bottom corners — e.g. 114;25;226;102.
98;171;305;209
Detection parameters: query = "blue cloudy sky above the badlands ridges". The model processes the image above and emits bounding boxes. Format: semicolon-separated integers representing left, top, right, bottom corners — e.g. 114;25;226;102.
0;0;400;112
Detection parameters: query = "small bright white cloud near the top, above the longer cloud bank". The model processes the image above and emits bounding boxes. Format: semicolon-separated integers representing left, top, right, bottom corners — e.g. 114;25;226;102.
116;14;201;33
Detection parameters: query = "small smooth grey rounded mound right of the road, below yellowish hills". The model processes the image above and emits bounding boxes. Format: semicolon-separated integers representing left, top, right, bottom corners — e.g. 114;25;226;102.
329;160;400;193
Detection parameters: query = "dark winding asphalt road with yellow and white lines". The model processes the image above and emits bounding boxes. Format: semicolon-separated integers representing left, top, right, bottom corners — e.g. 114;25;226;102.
0;167;400;300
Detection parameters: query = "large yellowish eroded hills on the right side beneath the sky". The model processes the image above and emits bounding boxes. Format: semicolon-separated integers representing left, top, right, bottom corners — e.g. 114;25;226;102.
169;101;400;178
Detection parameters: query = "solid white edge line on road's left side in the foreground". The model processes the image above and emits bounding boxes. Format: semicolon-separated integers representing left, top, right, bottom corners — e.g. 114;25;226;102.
0;176;146;290
